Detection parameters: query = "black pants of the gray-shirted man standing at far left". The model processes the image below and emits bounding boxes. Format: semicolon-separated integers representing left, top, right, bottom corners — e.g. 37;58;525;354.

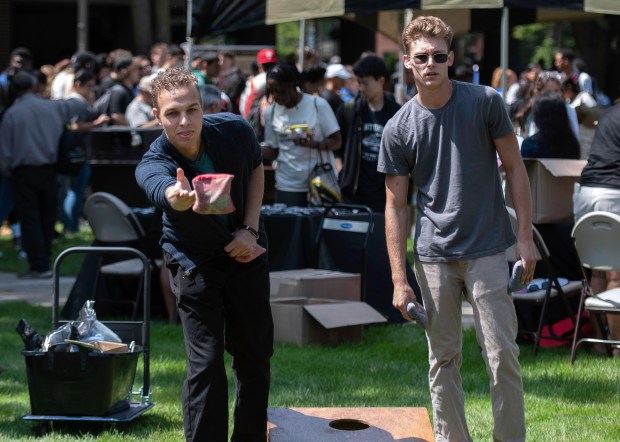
11;165;58;272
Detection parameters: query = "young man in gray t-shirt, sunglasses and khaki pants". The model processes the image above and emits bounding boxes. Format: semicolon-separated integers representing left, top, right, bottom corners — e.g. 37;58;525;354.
378;17;536;441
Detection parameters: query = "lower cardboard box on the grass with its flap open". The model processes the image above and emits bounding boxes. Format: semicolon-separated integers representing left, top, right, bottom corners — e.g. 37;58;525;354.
271;298;387;345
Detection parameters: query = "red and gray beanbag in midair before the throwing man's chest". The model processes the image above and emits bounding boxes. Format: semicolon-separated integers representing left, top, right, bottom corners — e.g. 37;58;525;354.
192;173;235;215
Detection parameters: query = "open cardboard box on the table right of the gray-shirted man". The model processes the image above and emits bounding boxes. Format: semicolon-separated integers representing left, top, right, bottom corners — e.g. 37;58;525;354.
506;158;587;224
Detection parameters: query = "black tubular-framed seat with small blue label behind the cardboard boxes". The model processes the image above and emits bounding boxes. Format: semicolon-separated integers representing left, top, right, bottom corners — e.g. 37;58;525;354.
314;204;374;301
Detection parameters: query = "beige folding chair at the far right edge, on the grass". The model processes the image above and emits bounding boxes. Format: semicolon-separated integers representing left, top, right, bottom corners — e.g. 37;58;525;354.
570;212;620;364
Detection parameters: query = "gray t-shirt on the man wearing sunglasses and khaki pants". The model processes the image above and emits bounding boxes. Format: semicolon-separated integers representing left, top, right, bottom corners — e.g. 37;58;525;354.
377;81;515;262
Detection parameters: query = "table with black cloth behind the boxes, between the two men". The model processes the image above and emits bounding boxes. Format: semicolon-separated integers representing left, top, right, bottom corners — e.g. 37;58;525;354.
261;205;421;323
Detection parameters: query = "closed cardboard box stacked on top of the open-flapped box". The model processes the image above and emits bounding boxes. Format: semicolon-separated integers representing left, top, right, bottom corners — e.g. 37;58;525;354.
269;269;361;301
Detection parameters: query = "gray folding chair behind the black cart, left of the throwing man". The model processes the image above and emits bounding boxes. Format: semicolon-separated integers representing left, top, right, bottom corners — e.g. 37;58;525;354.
84;192;158;320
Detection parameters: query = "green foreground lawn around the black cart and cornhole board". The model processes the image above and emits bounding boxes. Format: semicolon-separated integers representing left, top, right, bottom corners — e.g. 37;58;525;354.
0;302;620;442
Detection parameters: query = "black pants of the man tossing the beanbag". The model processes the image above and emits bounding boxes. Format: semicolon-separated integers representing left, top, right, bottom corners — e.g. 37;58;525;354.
167;257;273;442
